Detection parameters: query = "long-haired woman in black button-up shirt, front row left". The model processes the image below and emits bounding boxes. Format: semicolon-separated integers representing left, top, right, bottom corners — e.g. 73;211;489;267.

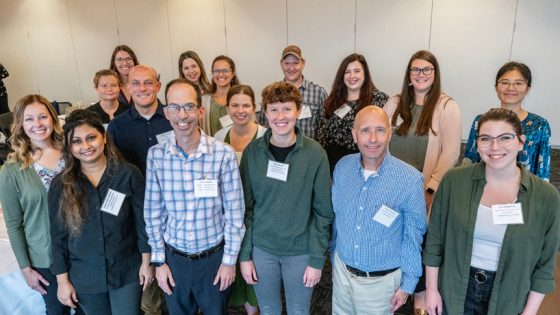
49;109;153;314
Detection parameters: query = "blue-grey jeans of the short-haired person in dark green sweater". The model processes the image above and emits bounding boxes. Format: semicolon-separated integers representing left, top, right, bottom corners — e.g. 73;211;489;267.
253;247;313;315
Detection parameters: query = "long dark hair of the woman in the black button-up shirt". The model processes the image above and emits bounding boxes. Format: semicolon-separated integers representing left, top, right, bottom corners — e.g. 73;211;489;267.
58;109;122;236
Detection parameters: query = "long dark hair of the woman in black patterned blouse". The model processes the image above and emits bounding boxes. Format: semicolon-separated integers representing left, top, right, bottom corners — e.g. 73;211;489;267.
325;54;377;118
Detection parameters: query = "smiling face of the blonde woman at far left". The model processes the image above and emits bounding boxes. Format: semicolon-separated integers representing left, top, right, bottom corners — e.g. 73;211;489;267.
23;102;53;145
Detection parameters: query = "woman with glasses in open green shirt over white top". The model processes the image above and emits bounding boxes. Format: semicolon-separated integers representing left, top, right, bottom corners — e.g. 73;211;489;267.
424;108;560;315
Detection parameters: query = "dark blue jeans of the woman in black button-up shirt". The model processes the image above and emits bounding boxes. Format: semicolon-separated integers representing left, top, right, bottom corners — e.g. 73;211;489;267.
78;281;142;315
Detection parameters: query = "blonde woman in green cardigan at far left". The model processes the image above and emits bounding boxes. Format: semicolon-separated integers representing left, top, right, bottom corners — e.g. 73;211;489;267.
0;95;69;314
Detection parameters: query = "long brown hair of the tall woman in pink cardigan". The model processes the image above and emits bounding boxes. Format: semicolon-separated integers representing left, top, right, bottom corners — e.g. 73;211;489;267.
391;50;441;136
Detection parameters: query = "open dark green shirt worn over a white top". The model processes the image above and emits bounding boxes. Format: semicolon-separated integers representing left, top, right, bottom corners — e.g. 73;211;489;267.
423;163;560;315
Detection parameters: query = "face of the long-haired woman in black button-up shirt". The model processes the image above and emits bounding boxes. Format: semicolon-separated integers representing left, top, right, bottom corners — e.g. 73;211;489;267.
70;124;107;164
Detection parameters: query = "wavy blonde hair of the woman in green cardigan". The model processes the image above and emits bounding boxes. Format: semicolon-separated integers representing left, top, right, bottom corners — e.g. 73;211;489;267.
8;94;63;169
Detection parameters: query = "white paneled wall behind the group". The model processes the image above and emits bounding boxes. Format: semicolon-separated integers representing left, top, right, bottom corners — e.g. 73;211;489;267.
0;0;560;145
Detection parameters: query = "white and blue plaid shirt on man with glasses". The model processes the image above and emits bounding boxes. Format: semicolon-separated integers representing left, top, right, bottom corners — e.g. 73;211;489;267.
144;131;245;265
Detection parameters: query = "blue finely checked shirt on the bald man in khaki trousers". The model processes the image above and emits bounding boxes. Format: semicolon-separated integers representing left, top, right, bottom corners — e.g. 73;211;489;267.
332;153;427;293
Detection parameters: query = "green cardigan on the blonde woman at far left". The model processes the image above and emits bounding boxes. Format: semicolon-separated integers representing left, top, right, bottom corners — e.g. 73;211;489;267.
0;163;51;269
